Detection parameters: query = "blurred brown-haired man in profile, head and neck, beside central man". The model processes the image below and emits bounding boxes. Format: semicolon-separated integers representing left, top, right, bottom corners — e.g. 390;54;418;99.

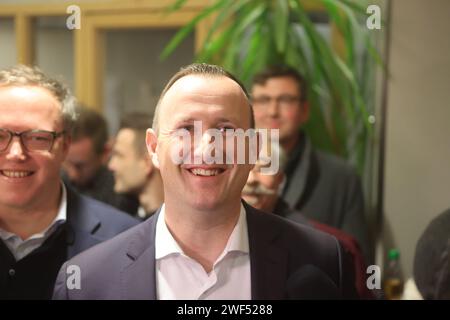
108;112;164;219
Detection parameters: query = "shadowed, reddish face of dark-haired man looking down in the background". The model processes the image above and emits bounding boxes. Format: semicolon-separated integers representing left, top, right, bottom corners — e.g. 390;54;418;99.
63;137;103;187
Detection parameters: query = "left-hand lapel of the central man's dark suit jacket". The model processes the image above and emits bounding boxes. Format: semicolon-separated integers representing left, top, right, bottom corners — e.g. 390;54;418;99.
120;210;159;300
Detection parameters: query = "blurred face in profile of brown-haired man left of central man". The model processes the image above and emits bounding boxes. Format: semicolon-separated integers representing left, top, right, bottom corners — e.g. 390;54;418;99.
108;129;151;194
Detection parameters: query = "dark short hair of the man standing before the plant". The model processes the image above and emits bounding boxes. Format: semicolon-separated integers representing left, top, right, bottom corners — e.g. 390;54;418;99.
253;65;308;102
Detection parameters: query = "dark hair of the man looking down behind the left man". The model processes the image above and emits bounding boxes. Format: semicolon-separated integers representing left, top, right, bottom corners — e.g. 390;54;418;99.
72;104;108;155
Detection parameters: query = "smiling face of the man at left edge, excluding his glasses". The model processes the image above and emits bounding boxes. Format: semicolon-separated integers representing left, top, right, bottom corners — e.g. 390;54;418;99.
0;86;69;211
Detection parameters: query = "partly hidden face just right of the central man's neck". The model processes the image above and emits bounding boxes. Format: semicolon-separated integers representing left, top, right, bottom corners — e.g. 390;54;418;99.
242;163;283;212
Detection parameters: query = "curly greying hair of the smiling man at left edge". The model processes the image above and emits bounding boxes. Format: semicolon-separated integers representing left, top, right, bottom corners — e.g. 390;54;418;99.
0;65;77;134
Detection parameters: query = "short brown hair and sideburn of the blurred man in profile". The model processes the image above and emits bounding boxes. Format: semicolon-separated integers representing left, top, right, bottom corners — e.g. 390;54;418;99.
119;112;153;156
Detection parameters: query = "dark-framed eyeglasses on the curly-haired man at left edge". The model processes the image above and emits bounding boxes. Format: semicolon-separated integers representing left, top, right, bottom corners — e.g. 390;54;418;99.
0;129;65;152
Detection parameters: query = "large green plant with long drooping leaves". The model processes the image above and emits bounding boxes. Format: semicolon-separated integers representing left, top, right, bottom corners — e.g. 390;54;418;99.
161;0;381;173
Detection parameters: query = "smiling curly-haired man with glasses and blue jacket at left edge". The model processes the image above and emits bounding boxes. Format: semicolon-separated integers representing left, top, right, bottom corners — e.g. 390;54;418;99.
0;66;137;299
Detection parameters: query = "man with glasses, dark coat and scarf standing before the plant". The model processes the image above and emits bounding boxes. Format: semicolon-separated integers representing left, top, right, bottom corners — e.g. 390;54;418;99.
251;66;373;263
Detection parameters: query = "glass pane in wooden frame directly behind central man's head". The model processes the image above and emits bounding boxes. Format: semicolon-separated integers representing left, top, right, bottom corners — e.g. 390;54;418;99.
103;29;194;134
